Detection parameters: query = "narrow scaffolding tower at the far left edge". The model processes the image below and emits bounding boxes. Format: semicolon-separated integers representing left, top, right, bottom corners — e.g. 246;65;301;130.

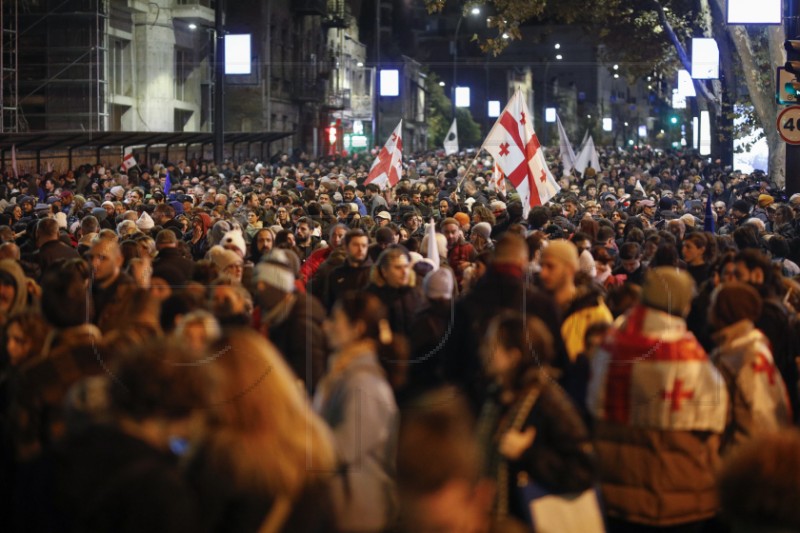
0;0;19;133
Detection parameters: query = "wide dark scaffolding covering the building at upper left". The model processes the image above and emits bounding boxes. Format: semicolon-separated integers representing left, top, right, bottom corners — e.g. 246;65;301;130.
15;0;109;132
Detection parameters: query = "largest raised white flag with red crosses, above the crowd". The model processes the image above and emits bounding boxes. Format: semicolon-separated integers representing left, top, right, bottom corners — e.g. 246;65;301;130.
483;90;561;217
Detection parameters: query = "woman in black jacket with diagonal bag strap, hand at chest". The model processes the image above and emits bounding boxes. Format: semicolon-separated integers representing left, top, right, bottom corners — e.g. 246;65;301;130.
479;312;593;520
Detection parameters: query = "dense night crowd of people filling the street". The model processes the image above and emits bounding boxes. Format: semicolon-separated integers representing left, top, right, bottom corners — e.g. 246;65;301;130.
0;143;800;532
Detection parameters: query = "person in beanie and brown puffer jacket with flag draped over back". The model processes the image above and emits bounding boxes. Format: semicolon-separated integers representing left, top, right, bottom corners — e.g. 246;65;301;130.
586;267;728;531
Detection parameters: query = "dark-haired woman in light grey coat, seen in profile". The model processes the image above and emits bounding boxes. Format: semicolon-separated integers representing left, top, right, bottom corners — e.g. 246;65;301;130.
314;292;399;532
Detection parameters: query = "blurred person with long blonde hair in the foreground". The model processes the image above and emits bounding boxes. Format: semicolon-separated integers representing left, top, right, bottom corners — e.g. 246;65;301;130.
187;328;335;532
